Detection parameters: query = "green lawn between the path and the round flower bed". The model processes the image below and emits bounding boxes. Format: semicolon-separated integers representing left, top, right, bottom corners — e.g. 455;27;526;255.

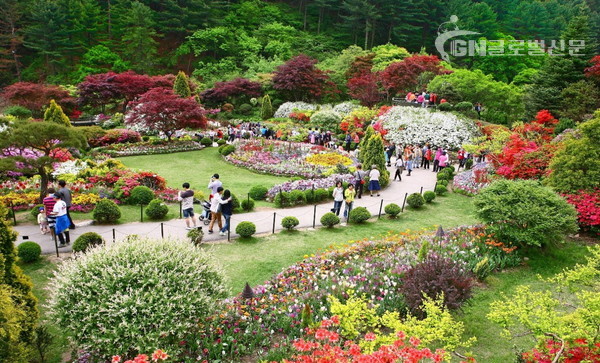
119;147;289;206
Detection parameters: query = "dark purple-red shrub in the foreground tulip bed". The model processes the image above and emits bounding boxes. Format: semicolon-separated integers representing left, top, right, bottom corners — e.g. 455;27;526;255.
400;255;473;315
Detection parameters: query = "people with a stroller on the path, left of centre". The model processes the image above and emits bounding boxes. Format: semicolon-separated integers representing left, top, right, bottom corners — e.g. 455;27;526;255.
177;174;233;236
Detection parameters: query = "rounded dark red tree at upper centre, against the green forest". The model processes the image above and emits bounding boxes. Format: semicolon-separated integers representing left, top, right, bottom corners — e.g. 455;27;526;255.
273;54;337;101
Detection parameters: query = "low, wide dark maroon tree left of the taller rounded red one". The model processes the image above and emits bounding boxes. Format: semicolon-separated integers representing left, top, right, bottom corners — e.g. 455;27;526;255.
200;78;262;105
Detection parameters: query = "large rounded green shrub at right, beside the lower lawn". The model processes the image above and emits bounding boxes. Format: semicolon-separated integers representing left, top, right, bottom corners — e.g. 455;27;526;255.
473;180;577;246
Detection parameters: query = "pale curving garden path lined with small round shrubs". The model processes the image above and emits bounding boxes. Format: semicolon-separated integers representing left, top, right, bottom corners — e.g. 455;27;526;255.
14;167;436;254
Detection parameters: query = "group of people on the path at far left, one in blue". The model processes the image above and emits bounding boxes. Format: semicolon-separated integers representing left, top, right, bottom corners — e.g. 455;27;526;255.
37;180;75;247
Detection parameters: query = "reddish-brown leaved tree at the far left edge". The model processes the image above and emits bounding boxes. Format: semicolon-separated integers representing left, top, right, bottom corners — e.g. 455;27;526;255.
0;82;75;116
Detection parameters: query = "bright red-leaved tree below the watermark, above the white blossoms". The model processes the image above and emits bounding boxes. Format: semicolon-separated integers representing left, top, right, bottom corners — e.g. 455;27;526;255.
381;55;450;95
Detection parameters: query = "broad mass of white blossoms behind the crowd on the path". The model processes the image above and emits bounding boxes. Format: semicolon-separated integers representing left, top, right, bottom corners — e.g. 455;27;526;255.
378;106;477;149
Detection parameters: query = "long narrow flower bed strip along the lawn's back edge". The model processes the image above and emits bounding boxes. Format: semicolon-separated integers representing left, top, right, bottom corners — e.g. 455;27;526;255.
95;140;203;157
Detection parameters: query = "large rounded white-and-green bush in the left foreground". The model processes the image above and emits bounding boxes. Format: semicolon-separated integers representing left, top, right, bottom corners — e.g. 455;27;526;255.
49;238;226;361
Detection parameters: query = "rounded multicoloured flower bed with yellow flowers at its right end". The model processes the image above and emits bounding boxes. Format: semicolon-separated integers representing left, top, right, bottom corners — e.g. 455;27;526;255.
225;139;353;178
